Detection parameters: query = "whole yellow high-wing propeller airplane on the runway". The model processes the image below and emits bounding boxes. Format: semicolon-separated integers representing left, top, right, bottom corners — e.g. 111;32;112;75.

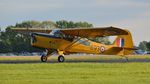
12;27;134;62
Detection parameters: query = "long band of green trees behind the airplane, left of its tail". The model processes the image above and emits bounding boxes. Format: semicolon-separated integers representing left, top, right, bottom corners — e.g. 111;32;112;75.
0;20;108;53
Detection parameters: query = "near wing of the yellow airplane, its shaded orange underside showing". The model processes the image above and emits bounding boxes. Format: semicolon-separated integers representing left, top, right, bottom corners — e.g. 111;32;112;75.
61;27;128;37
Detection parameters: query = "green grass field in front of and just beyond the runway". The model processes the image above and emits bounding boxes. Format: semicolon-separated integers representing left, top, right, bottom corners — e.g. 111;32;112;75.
0;57;150;84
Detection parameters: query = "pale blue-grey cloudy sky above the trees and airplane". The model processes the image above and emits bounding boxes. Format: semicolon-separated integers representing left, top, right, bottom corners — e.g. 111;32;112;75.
0;0;150;45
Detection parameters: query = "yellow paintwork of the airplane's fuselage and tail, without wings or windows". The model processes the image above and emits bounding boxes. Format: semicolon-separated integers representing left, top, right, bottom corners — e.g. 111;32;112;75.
29;30;134;55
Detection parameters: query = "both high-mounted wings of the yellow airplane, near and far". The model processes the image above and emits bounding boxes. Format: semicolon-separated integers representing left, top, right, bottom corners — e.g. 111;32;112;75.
12;27;128;37
